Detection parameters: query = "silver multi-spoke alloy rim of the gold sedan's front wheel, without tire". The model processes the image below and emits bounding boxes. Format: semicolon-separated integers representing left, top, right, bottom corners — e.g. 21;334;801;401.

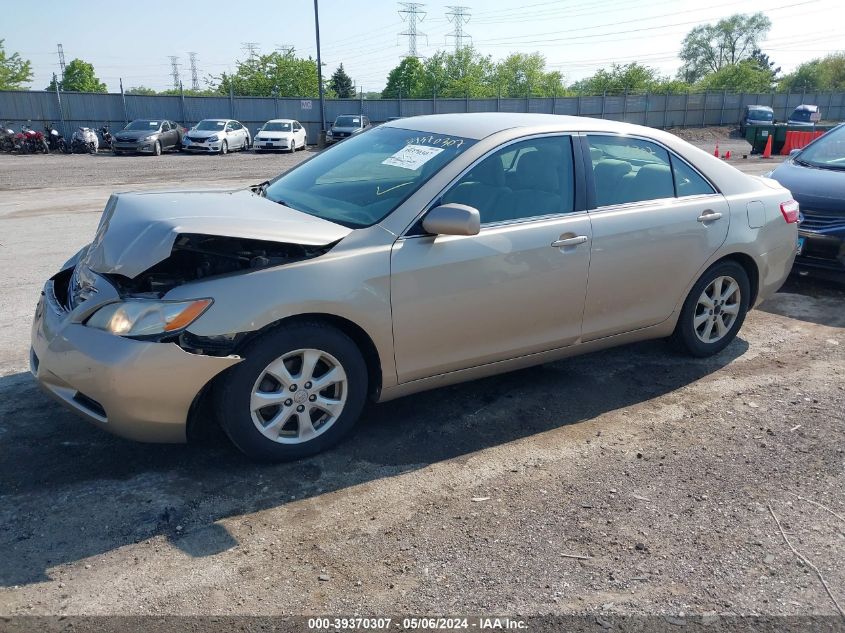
250;349;349;444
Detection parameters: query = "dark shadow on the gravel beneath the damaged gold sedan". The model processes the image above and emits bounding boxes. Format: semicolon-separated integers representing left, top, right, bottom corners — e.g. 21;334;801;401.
0;339;748;586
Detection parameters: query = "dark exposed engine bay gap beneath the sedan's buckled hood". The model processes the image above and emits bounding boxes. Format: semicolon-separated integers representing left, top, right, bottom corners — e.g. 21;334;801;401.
109;233;337;297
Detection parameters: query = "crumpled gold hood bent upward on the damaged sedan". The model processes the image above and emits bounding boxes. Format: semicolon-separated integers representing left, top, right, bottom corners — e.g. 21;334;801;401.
80;189;352;278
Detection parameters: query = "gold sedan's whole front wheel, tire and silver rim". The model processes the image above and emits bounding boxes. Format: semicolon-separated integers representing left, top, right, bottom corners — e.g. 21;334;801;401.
215;322;367;461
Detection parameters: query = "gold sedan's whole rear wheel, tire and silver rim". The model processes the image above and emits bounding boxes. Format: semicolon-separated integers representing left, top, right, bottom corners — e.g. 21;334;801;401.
670;261;751;357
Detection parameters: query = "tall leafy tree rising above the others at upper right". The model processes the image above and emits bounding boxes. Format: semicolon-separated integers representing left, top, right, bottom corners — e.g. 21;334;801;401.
678;12;772;83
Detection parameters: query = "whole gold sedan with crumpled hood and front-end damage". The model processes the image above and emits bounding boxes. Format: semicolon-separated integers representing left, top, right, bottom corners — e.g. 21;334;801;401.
31;113;798;459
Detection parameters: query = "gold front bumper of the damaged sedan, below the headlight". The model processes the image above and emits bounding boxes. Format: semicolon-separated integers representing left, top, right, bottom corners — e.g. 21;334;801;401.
30;280;241;442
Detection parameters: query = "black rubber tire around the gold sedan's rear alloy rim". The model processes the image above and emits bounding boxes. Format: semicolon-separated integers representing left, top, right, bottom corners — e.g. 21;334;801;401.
669;260;751;358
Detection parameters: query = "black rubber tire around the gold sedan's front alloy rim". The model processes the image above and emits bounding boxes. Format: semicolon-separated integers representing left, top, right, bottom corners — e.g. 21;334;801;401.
214;322;368;461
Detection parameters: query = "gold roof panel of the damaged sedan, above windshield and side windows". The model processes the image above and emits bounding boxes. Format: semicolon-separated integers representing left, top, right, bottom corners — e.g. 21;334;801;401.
382;112;657;139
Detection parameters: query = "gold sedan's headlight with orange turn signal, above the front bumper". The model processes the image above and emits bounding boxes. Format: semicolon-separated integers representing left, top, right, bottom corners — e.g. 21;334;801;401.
85;299;213;336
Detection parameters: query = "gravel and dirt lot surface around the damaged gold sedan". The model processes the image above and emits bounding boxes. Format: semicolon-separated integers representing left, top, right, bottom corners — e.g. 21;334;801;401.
0;140;845;615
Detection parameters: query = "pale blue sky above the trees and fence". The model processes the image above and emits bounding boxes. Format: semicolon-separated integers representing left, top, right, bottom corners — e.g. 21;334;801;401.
6;0;845;91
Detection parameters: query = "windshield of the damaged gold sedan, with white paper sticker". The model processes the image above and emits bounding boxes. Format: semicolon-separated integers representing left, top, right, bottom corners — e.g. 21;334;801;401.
265;127;475;228
